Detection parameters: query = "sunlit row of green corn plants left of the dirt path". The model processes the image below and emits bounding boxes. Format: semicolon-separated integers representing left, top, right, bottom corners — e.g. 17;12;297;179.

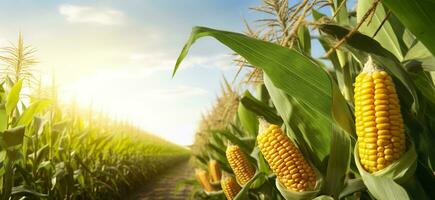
0;78;189;200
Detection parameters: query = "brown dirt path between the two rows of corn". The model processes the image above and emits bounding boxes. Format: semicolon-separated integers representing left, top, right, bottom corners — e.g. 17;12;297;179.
129;161;193;200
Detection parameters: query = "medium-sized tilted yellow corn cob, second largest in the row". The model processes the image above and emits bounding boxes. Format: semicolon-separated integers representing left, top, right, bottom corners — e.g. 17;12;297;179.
257;125;316;192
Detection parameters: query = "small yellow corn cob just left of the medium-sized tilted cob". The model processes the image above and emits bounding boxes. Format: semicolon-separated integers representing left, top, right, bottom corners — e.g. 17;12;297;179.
226;145;255;185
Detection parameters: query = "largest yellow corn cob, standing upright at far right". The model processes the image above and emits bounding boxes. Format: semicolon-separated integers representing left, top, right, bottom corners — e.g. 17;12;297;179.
354;58;406;173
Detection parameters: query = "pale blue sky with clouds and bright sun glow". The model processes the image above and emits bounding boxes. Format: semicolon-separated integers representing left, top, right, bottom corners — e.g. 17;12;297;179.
0;0;338;144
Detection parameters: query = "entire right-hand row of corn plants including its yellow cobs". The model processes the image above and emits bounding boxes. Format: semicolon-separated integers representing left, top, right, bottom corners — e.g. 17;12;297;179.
174;0;435;200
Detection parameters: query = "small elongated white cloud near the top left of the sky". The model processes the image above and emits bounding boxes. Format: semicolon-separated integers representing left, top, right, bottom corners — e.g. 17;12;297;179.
59;4;125;25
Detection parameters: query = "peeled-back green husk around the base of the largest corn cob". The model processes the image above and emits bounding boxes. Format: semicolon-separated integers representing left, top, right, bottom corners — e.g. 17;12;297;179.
354;142;417;200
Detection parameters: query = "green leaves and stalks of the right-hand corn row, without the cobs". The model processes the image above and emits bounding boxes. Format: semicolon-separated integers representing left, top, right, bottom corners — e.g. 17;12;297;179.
173;0;435;199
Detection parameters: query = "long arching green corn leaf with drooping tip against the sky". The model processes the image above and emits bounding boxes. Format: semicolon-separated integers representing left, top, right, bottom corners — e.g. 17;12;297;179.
173;27;338;133
